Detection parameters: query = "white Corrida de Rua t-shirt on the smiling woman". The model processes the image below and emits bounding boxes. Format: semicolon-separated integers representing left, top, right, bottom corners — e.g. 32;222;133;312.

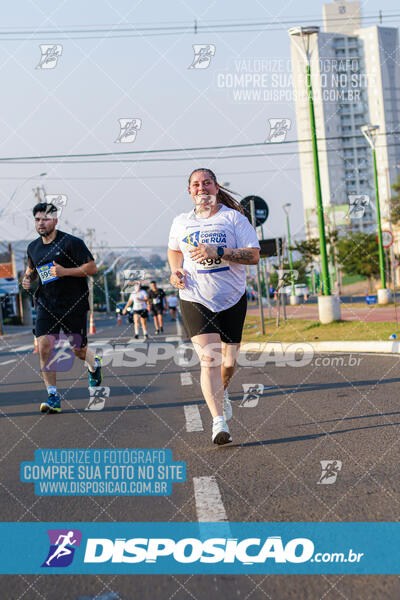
168;205;260;312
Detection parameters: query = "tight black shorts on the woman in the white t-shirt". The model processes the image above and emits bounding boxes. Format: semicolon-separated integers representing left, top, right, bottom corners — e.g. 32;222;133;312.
180;294;247;344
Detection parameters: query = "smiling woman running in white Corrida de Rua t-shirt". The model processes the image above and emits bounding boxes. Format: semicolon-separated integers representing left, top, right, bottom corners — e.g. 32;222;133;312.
168;169;260;445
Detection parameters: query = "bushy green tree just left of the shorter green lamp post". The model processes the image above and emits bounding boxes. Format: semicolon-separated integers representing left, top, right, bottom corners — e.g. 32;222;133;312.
338;231;379;291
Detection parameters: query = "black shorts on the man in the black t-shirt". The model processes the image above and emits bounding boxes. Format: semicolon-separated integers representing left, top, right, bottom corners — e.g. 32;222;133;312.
34;305;87;348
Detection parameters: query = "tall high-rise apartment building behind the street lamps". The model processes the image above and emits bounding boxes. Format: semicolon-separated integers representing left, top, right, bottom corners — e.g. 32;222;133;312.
291;1;400;251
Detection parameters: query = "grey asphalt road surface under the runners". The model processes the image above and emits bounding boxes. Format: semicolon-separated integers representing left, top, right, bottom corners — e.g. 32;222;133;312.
0;317;400;600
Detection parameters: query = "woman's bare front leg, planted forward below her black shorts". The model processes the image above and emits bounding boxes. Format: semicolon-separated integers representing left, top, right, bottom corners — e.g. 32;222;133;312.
192;333;224;418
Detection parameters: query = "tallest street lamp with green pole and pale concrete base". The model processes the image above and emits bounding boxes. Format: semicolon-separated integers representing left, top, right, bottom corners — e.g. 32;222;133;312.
289;25;340;323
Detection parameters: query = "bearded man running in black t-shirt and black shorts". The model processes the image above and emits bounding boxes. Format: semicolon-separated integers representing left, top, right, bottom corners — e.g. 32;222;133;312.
22;202;103;413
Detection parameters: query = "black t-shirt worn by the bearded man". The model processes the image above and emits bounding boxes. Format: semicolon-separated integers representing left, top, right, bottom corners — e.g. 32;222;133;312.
27;231;94;314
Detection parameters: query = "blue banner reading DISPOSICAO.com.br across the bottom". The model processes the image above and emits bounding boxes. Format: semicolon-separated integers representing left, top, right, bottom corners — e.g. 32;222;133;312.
0;522;400;575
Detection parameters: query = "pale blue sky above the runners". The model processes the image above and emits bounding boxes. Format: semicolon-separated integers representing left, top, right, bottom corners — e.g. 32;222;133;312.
0;0;400;253
